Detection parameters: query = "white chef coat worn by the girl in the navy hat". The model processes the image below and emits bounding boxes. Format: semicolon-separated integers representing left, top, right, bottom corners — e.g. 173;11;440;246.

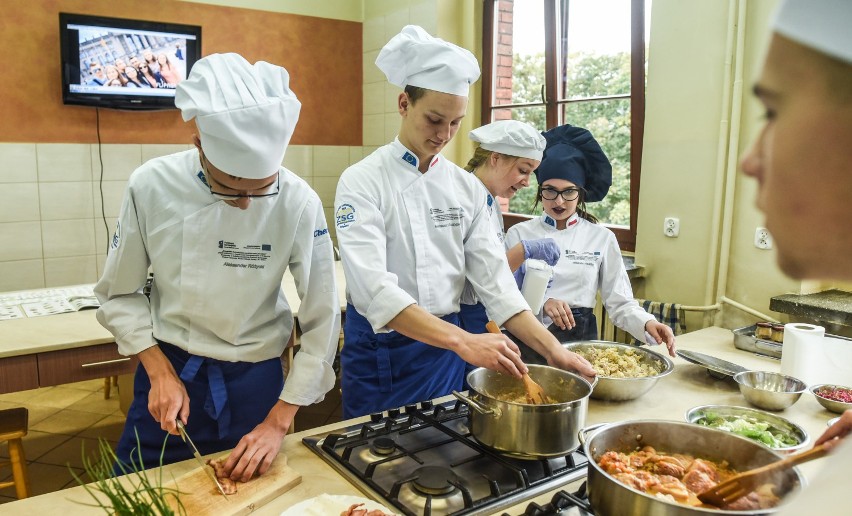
505;213;655;342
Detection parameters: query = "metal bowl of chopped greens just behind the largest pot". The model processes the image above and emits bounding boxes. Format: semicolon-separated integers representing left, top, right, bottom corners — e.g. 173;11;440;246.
686;405;810;453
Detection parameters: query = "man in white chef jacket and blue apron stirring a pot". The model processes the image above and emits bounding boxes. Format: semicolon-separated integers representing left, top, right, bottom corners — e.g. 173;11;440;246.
335;25;594;417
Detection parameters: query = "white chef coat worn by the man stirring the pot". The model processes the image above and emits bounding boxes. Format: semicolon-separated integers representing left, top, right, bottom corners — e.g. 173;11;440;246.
334;139;529;333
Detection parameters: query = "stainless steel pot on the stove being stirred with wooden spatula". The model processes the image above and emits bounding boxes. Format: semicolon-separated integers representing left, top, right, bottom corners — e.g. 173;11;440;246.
453;365;592;459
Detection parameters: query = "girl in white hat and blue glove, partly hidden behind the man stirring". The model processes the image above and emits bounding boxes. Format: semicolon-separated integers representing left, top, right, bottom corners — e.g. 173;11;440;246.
459;120;559;338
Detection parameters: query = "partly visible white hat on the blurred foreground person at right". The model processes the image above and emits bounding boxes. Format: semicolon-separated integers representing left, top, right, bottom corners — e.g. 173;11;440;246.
773;0;852;63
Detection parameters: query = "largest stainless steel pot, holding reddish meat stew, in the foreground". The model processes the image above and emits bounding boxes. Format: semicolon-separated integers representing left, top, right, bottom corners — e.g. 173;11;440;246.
581;420;804;516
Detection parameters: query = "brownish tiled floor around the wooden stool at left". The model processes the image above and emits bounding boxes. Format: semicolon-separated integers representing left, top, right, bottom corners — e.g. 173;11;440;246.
0;380;341;506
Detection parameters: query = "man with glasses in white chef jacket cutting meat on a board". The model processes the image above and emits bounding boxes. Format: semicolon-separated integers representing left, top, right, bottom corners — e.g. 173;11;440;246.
95;54;340;481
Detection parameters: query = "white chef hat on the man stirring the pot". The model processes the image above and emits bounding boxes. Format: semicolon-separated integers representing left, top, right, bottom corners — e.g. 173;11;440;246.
376;25;479;97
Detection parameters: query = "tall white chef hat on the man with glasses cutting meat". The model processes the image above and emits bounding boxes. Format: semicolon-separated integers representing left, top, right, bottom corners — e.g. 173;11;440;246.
175;54;302;179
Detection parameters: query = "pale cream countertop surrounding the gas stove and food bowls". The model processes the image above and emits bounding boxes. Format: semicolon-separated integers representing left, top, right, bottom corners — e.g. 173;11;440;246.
2;327;837;516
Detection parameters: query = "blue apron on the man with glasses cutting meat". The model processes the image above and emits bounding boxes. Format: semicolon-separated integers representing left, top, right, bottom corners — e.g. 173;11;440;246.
115;341;284;474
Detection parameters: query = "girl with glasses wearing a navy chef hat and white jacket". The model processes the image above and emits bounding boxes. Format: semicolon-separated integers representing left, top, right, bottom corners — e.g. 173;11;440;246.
506;124;675;356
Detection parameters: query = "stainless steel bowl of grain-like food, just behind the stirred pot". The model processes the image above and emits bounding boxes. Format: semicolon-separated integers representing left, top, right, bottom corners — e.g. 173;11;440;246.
562;340;674;401
